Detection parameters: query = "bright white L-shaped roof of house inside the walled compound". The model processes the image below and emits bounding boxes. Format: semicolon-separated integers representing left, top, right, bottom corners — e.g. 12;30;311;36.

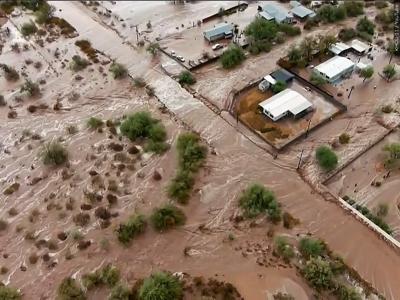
259;89;312;118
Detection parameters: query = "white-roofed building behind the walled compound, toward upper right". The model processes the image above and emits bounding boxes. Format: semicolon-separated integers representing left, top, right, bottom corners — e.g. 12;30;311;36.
314;56;355;83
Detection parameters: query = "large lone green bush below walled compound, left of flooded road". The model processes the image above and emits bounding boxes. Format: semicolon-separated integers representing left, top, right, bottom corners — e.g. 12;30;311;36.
239;184;281;221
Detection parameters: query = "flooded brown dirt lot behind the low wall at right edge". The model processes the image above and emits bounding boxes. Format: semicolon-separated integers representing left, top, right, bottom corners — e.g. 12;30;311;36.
326;131;400;239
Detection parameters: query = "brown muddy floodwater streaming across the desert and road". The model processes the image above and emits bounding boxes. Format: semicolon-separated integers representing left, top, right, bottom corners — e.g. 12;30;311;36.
0;1;400;300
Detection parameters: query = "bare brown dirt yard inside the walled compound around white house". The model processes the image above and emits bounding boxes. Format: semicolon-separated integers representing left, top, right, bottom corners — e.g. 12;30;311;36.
235;79;339;148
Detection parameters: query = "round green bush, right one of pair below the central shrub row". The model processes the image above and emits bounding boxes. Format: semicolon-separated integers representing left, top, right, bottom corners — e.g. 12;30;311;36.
150;204;186;231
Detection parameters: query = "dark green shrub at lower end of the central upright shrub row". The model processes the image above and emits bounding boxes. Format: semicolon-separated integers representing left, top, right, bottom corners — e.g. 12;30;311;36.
168;170;194;204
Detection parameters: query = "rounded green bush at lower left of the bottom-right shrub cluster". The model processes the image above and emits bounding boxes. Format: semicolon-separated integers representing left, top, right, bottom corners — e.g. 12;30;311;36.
302;257;333;291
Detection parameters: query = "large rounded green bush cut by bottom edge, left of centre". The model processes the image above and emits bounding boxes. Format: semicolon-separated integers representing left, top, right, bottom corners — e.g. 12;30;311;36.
139;272;183;300
